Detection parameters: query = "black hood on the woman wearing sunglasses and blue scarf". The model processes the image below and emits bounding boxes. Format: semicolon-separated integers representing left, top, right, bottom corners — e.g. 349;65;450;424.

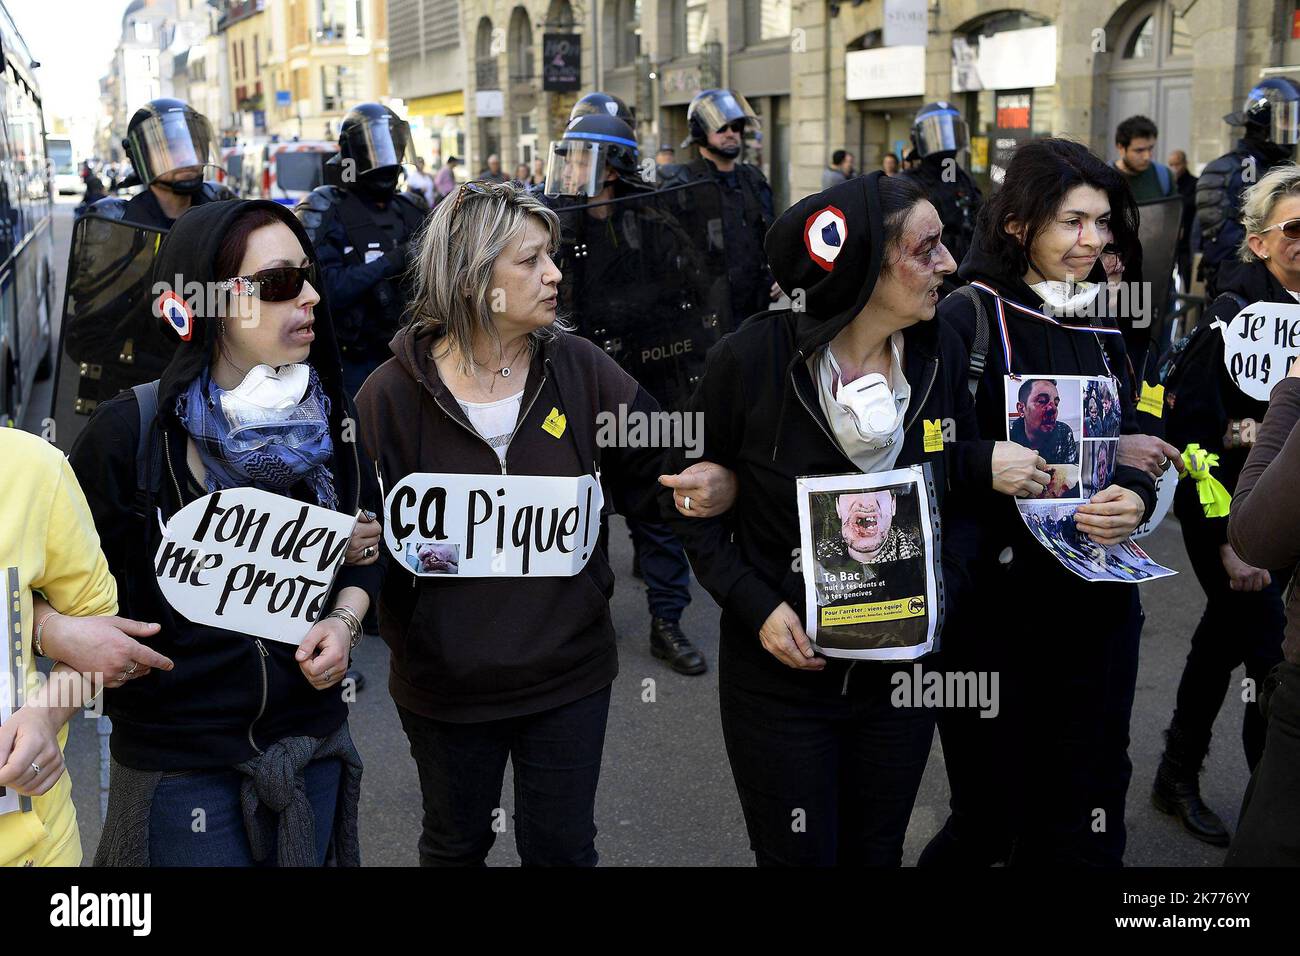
151;199;347;423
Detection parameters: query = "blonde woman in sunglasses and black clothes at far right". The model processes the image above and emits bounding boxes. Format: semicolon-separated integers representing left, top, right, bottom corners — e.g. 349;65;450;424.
1152;163;1300;847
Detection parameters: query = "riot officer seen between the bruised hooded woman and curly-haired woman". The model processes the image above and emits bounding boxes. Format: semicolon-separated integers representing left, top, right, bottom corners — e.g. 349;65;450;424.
902;100;984;294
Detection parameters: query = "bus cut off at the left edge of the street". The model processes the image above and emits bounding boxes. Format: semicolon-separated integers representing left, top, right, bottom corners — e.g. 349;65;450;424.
0;3;57;424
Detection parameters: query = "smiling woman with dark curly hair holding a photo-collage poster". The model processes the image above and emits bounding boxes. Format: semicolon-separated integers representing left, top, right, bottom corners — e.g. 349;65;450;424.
920;139;1154;865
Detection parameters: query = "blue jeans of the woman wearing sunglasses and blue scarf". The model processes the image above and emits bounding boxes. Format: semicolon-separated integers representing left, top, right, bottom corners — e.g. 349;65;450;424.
150;757;343;866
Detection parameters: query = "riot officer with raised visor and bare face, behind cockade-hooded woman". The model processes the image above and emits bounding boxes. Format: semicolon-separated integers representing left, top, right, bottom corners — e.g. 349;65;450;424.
663;90;781;324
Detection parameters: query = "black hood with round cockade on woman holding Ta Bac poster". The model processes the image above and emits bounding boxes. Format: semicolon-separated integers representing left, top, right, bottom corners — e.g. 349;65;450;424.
763;170;884;354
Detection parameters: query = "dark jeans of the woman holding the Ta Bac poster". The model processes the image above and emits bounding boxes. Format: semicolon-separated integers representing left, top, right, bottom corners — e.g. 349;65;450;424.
719;665;935;866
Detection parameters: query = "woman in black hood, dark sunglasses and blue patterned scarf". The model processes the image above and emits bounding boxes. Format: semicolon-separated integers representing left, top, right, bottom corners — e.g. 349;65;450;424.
70;200;382;866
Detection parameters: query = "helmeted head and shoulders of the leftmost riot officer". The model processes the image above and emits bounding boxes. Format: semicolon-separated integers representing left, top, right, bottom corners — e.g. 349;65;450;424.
91;98;235;229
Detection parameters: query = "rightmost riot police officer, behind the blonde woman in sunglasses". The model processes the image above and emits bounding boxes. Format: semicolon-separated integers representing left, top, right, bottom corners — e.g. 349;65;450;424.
1196;77;1300;299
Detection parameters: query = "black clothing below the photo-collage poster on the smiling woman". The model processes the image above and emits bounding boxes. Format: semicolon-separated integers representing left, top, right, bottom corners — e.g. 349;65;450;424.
918;567;1143;868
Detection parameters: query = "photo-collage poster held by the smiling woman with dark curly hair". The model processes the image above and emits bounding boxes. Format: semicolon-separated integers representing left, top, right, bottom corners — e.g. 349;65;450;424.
1006;375;1175;583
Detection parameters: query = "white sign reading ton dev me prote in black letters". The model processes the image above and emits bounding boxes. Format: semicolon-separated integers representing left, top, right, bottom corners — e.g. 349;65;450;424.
153;488;356;644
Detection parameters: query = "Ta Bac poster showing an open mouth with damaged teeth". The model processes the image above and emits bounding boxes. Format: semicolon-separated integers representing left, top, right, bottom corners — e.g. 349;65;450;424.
797;466;943;661
